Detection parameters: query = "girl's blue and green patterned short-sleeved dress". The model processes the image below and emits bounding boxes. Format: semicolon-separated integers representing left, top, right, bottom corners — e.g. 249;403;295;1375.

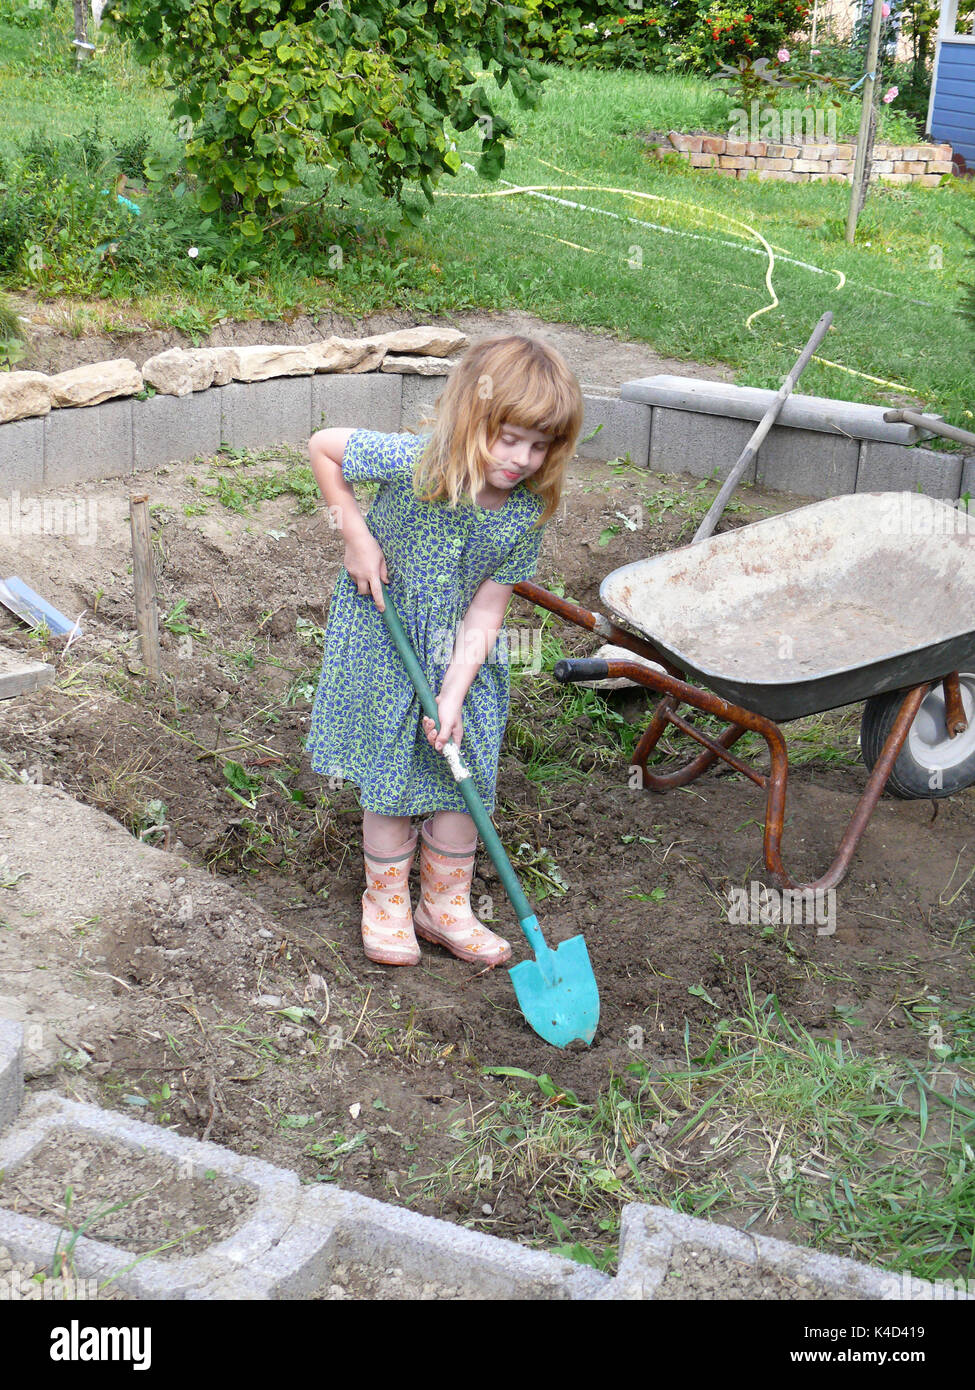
306;430;542;816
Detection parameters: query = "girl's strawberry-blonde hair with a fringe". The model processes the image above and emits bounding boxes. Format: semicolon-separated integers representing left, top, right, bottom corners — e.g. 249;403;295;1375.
413;334;583;525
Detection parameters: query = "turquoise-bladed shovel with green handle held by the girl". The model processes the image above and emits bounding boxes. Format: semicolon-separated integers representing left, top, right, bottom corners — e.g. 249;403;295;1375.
382;584;599;1047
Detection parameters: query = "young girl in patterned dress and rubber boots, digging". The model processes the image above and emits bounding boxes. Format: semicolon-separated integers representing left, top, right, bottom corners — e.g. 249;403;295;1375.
306;336;583;966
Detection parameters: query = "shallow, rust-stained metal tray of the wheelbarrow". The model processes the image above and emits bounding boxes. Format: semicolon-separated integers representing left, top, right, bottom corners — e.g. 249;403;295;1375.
599;492;975;720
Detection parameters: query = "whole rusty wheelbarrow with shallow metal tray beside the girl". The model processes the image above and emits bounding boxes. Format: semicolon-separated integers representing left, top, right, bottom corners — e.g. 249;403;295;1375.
515;492;975;891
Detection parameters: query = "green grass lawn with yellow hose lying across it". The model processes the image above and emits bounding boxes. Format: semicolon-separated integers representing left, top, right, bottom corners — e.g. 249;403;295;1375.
0;10;975;428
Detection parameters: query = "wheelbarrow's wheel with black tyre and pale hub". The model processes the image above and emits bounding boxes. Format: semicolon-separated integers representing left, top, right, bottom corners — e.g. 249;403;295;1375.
860;671;975;801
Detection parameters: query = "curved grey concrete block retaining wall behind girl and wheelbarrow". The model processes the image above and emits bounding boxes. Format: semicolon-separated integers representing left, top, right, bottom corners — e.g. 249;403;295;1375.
0;373;975;499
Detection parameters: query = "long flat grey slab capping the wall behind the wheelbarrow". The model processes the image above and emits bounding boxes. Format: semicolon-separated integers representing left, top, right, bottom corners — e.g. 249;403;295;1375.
619;375;940;443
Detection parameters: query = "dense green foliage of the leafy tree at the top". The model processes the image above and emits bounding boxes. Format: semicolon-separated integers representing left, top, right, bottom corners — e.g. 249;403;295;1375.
106;0;544;225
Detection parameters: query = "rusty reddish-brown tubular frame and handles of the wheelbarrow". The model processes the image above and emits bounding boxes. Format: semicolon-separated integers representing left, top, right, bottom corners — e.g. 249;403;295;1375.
515;581;968;892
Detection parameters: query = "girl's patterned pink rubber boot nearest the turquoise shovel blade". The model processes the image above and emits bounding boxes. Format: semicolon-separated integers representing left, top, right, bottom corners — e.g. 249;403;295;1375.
414;820;512;966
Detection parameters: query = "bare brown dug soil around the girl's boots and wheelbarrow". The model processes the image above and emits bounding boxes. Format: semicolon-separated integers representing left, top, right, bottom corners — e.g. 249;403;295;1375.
0;316;975;1273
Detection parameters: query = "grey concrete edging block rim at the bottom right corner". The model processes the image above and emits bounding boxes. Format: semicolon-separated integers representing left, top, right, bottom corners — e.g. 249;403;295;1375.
601;1202;971;1302
